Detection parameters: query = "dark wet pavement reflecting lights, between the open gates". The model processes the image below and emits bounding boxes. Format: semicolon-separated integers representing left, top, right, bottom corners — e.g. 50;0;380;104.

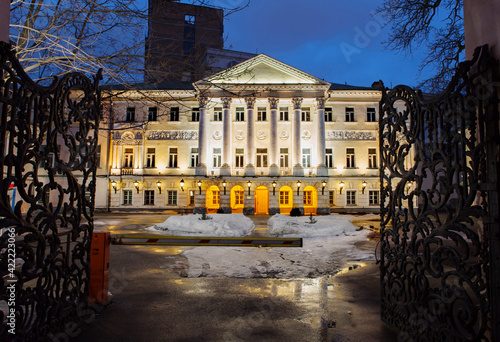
73;213;397;342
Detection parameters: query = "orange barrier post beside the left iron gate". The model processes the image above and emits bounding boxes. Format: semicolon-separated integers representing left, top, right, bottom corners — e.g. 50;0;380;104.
89;232;110;304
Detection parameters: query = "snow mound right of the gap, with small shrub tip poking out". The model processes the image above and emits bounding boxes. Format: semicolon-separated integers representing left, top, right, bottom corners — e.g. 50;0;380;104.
267;214;359;238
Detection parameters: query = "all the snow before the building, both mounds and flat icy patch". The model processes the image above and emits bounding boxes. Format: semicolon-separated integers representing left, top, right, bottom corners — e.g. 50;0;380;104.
149;214;374;278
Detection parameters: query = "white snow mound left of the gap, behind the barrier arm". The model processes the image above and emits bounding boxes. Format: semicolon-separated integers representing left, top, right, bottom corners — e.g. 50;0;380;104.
146;214;254;237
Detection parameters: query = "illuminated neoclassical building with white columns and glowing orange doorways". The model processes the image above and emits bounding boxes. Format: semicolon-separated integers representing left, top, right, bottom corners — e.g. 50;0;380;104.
96;54;380;214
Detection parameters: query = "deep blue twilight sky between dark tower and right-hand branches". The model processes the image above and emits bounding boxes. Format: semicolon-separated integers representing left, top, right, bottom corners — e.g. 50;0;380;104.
217;0;432;86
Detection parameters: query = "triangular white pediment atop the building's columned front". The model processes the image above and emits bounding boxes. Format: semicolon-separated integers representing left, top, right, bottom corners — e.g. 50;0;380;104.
195;54;329;85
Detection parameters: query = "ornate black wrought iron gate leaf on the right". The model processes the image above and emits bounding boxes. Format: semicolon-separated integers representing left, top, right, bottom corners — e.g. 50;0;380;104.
379;46;500;341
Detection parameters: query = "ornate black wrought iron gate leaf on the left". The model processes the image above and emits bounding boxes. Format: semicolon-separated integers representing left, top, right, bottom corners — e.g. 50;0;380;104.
0;42;100;341
